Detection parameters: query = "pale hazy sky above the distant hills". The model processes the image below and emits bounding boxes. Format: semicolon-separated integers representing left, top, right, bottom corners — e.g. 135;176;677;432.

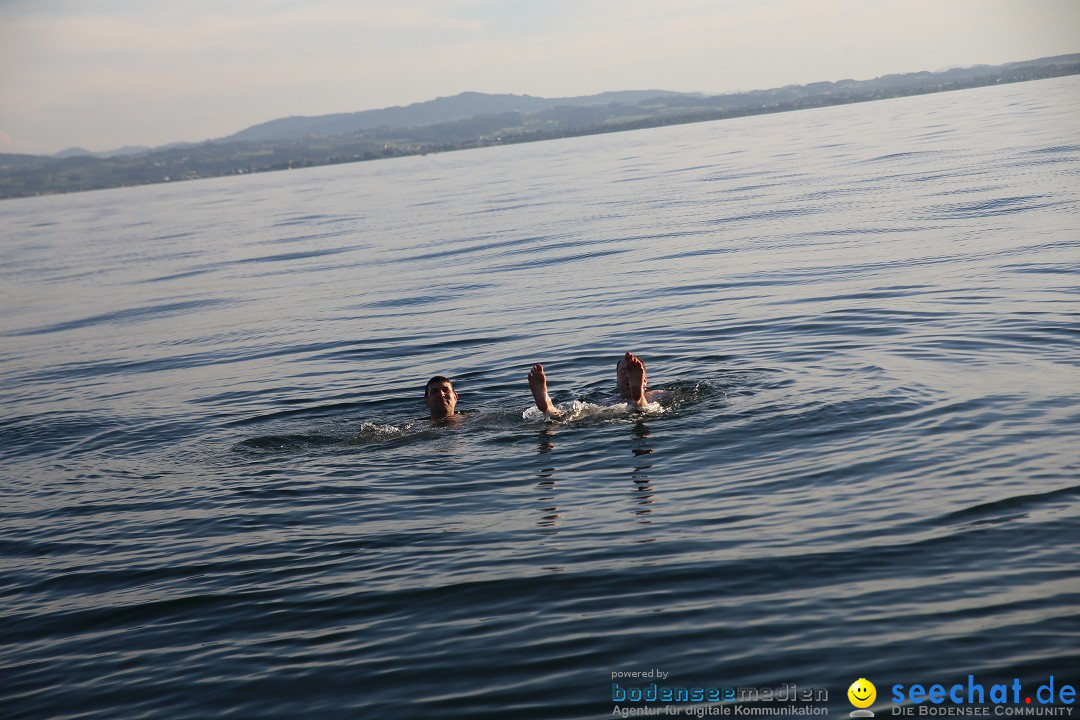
0;0;1080;153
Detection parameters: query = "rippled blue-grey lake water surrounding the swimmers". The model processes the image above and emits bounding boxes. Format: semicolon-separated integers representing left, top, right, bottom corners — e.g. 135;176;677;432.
0;78;1080;720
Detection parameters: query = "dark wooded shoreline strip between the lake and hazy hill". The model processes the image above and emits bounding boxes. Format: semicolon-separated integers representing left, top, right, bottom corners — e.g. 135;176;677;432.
0;55;1080;200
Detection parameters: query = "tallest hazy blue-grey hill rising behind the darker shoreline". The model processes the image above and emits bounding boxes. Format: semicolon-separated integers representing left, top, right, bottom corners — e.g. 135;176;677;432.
223;90;700;142
